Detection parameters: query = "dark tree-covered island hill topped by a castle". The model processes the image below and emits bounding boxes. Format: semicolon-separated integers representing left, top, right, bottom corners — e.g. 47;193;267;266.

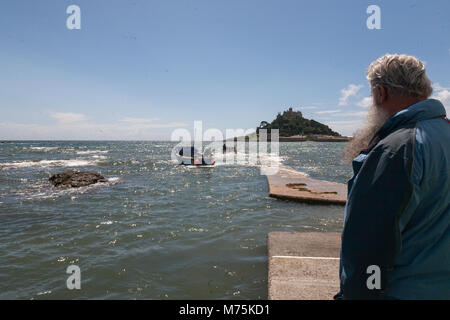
256;108;341;137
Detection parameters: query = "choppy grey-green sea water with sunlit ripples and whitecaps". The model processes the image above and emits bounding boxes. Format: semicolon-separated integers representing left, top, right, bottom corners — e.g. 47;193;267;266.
0;141;351;299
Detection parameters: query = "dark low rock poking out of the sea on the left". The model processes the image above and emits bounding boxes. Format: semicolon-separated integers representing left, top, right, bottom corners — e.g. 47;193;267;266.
48;170;108;188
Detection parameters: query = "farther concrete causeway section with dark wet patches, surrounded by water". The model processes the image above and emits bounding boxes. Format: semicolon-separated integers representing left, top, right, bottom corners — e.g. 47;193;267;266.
266;166;347;205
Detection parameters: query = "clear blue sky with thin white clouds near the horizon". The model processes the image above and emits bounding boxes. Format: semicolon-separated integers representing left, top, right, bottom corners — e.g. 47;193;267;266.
0;0;450;140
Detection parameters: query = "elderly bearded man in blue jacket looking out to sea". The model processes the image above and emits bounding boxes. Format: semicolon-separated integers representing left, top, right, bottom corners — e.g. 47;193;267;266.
335;54;450;299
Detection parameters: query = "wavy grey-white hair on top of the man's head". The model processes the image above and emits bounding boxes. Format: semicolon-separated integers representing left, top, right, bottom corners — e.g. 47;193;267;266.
367;54;433;98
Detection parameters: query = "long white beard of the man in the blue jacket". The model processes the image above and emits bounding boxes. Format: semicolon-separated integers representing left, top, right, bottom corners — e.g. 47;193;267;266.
342;103;389;164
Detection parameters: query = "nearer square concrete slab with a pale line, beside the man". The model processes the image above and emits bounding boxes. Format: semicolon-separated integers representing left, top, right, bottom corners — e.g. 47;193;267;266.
267;232;341;300
